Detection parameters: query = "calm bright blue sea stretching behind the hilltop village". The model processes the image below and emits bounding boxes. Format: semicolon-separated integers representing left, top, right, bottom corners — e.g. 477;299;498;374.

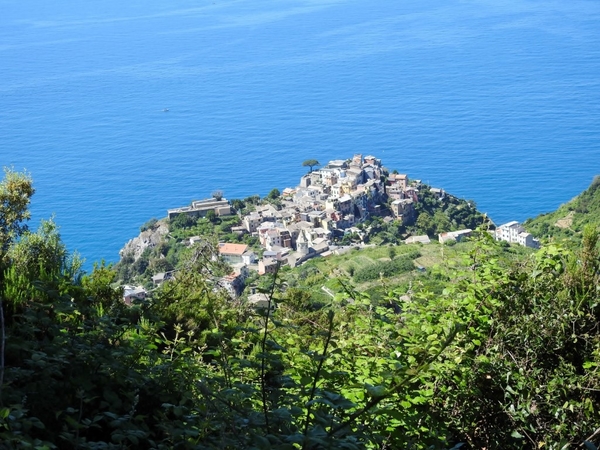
0;0;600;268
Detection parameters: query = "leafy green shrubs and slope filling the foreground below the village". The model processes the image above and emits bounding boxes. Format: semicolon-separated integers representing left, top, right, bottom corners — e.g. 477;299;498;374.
0;171;600;450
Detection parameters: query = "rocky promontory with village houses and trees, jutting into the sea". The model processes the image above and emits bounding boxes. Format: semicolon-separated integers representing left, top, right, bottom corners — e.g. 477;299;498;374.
117;154;539;296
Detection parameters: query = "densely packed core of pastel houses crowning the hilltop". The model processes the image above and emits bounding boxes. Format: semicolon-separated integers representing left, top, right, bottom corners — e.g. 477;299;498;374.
167;155;412;268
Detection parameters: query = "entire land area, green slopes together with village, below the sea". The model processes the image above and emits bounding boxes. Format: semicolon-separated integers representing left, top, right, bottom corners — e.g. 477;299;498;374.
0;161;600;450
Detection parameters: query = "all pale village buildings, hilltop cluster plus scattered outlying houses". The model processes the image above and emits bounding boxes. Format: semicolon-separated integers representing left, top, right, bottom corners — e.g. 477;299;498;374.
122;154;538;300
